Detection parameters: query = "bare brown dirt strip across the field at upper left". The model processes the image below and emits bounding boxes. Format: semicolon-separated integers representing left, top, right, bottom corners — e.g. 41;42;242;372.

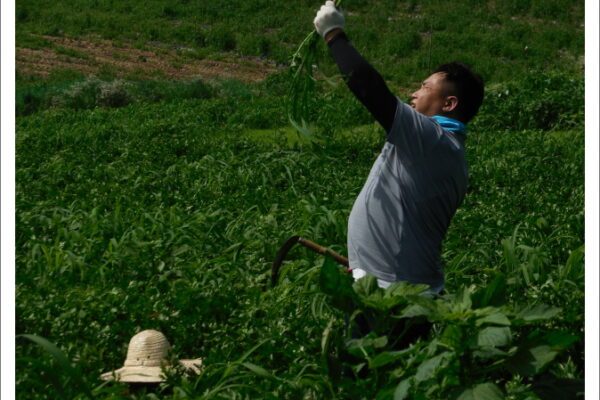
16;36;278;82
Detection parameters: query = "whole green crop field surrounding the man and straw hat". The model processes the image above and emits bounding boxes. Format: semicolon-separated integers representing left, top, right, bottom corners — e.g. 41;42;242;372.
15;0;585;400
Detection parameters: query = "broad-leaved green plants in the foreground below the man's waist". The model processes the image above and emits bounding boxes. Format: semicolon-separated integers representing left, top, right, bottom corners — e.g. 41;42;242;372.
321;262;583;399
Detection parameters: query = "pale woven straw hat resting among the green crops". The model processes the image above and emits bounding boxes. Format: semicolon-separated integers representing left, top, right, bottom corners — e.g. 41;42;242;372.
100;329;202;383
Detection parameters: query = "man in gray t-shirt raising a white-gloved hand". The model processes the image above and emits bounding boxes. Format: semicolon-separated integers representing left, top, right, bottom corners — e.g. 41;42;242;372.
314;1;483;293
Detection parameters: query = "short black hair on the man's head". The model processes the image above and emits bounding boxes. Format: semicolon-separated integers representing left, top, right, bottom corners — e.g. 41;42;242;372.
434;62;483;123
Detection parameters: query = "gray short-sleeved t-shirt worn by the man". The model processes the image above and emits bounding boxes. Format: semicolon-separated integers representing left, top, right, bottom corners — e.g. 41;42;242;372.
348;100;468;288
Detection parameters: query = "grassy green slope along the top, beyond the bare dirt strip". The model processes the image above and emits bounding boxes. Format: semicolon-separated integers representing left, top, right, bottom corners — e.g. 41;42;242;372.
16;0;584;87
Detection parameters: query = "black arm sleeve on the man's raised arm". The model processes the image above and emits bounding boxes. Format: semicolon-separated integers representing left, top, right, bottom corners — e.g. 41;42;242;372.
328;32;398;132
